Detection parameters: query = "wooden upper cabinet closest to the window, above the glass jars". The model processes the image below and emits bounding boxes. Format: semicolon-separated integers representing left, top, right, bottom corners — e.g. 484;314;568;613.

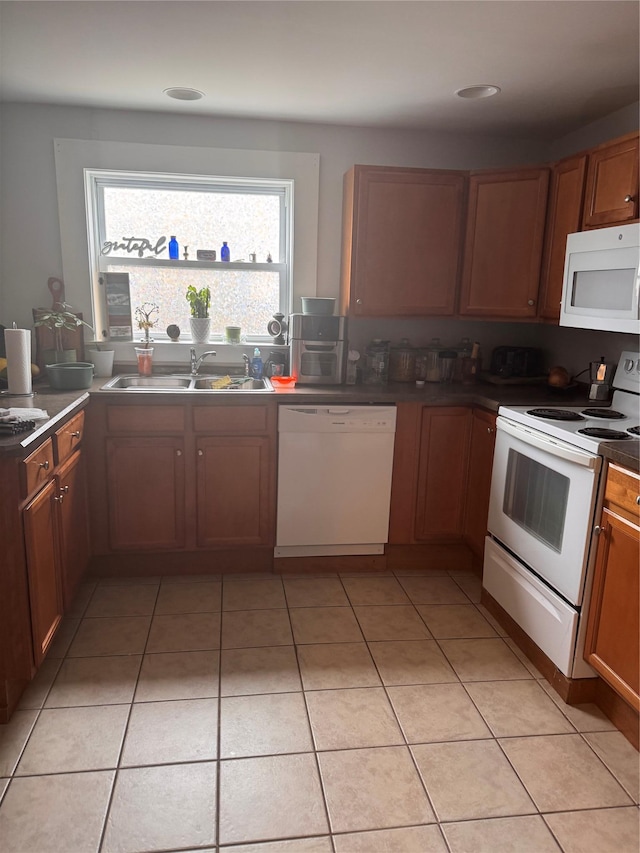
341;166;466;317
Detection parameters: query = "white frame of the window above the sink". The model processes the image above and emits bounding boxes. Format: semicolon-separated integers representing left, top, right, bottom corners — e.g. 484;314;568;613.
83;168;294;343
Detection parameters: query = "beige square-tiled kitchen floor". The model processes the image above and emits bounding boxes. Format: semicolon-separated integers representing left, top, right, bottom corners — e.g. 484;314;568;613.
0;572;640;853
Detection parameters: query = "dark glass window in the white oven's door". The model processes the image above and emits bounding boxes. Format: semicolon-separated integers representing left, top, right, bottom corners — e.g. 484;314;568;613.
502;448;570;554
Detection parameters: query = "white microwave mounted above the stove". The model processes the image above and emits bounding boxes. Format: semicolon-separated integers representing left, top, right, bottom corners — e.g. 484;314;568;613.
560;223;640;334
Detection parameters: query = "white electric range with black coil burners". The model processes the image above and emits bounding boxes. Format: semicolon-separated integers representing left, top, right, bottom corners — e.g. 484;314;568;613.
483;352;640;678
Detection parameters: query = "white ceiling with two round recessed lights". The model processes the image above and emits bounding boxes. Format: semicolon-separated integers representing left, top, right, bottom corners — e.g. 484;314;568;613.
0;0;640;138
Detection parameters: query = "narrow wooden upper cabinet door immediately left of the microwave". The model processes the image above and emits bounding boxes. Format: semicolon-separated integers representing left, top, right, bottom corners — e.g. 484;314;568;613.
539;154;587;321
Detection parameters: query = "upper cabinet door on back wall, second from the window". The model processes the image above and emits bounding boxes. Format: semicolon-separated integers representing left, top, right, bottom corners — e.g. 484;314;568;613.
460;168;549;319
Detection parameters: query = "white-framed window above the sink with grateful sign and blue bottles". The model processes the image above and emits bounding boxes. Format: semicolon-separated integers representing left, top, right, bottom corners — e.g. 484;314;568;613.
85;169;293;340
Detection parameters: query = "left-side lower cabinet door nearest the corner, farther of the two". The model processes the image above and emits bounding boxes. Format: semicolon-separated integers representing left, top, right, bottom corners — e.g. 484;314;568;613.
57;452;89;610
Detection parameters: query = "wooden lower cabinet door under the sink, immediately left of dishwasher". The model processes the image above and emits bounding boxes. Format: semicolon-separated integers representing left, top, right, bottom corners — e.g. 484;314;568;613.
196;436;275;548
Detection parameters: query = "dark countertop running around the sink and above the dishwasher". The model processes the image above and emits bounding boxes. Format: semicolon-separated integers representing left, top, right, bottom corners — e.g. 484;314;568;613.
0;378;626;454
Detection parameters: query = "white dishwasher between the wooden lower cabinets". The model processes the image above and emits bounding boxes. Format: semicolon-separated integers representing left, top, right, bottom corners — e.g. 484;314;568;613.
274;406;396;557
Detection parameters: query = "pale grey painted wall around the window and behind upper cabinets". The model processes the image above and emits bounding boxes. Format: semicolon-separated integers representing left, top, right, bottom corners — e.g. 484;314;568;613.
0;104;637;370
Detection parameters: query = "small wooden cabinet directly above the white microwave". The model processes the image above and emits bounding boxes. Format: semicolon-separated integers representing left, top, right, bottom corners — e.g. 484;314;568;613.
582;133;638;229
